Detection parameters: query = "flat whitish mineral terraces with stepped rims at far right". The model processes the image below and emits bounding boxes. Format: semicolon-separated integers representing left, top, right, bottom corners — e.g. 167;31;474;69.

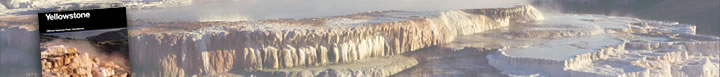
478;15;720;77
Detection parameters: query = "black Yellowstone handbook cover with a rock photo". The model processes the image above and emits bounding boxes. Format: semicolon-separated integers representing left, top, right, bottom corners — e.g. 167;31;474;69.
38;7;130;77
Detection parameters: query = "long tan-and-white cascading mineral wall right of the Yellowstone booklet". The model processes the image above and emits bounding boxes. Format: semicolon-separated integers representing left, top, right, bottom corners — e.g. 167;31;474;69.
130;5;543;72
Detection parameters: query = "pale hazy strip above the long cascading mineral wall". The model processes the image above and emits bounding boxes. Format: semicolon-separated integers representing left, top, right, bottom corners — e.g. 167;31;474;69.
129;0;528;20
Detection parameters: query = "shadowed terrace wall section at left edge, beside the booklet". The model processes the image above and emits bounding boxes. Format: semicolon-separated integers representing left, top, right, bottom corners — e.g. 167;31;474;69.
0;21;41;77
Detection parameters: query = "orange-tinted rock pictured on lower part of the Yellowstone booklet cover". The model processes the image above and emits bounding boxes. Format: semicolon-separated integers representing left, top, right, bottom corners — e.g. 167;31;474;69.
41;46;129;77
